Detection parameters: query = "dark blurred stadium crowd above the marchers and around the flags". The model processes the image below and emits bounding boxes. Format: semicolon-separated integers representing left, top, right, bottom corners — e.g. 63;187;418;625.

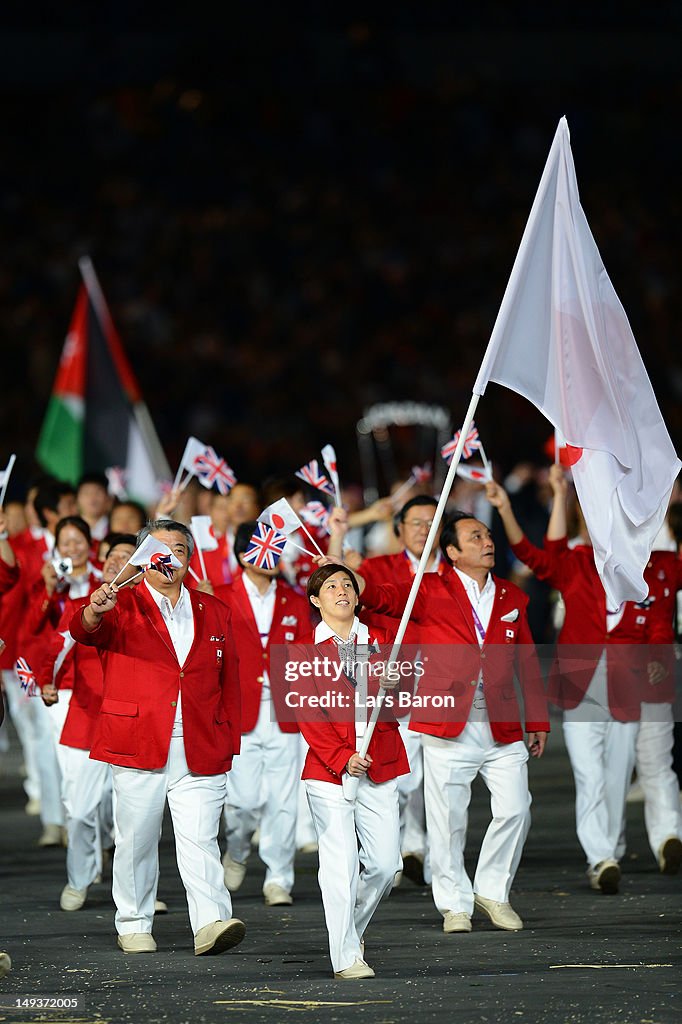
0;2;682;497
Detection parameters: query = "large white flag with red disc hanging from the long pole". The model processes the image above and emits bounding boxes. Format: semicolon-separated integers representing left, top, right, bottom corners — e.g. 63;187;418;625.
473;118;682;609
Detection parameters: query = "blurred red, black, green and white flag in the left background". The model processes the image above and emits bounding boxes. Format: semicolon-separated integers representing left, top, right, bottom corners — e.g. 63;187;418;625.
36;259;171;504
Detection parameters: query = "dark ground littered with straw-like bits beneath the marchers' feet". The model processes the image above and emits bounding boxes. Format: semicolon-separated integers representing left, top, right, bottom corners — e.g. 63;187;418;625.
0;725;682;1024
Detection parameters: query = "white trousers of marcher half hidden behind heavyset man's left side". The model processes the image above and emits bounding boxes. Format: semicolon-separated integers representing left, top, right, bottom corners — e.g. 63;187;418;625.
57;743;112;889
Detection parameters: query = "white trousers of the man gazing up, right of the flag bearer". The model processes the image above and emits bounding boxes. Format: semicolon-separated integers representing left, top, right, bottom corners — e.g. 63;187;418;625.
422;722;530;916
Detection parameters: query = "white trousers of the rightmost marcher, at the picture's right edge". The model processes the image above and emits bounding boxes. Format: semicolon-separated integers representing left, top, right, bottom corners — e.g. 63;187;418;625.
635;703;682;858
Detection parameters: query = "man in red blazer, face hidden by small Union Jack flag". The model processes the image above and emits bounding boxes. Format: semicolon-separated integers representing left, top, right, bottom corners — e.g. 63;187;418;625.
215;521;310;906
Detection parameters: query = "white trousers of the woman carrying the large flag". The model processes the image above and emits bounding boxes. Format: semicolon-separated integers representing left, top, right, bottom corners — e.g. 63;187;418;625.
305;776;401;971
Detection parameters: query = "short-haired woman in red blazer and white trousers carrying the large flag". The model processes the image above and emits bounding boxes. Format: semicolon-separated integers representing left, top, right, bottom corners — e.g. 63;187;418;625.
288;564;403;979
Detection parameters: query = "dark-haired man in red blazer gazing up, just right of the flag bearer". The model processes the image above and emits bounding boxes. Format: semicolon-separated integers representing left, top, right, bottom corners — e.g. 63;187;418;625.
350;512;549;933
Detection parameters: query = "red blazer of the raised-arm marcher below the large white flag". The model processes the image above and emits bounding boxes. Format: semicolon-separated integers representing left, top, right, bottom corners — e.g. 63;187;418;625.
512;537;674;722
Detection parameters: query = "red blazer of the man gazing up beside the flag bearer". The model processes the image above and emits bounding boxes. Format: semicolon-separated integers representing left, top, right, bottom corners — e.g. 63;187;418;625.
363;569;550;743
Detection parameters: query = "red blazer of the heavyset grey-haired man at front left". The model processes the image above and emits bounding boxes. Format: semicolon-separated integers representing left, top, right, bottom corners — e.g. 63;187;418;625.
69;586;241;775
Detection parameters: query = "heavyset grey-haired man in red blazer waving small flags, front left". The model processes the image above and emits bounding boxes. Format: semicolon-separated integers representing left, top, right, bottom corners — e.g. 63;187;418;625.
70;519;245;955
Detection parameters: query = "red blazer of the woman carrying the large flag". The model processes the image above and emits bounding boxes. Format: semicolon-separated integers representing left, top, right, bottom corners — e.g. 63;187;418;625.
289;630;410;785
